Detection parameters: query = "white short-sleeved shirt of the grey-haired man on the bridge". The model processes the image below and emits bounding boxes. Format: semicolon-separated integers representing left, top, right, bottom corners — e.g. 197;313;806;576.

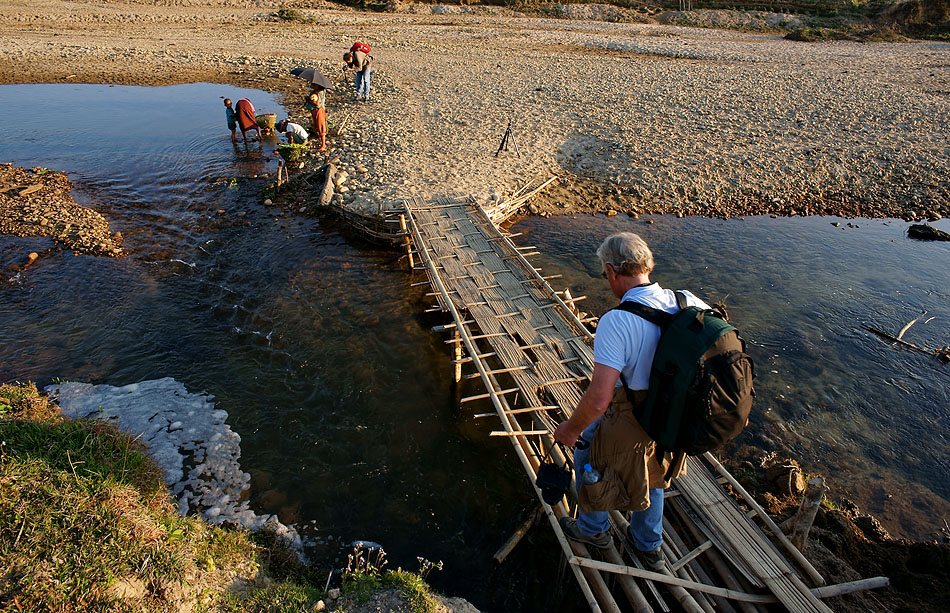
594;283;710;390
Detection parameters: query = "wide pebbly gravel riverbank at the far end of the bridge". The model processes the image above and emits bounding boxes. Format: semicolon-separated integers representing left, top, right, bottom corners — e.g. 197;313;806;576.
0;0;950;226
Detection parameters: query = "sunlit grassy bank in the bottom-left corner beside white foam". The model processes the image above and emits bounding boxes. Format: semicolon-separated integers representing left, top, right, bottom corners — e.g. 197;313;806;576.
0;384;319;612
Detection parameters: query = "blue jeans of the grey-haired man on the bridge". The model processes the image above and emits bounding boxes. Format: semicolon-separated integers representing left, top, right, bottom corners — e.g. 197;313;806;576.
574;419;663;551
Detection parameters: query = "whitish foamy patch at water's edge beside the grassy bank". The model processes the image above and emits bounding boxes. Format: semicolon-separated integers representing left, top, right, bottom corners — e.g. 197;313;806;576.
46;377;301;549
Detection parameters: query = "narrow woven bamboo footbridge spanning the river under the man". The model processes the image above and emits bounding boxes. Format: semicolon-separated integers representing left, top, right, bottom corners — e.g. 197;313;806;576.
400;198;887;613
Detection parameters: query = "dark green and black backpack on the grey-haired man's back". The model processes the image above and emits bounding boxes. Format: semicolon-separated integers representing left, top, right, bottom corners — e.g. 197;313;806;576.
612;292;755;455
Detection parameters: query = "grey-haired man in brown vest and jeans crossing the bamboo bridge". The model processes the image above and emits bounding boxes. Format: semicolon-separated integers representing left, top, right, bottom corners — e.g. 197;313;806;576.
554;232;709;572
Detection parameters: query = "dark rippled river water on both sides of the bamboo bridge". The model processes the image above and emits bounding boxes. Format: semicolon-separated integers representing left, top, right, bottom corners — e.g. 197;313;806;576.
0;84;950;611
